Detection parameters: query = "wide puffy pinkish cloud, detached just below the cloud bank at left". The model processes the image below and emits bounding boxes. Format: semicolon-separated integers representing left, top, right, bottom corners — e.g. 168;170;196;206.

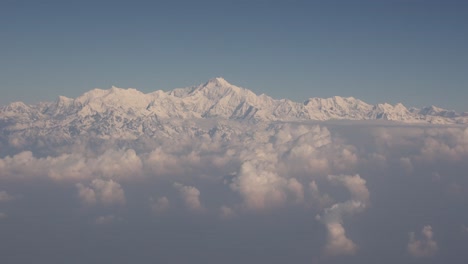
76;179;125;205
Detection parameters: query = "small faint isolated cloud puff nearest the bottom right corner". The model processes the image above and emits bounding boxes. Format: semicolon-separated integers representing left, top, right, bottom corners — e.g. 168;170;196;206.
408;225;439;258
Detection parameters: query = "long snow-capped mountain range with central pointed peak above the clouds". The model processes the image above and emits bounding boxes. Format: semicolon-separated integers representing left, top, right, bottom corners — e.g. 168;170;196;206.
0;78;468;148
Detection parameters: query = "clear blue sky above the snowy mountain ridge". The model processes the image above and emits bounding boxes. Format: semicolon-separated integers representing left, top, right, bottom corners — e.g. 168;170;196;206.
0;0;468;111
